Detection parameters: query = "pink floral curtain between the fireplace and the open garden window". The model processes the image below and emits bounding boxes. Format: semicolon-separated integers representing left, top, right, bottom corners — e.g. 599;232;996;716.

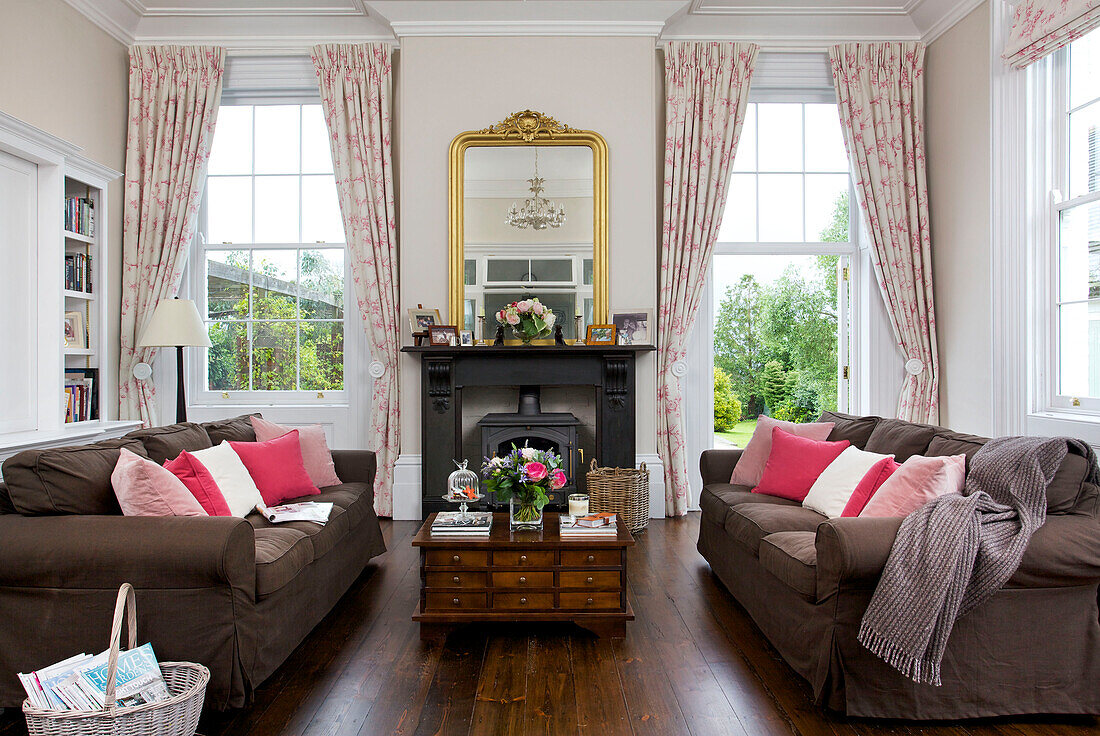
657;41;758;516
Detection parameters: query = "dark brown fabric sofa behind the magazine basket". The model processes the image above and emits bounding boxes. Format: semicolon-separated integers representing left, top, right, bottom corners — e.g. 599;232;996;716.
0;417;385;710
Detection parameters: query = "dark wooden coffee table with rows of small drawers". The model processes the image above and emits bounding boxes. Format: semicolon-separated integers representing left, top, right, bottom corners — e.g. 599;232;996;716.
413;513;634;639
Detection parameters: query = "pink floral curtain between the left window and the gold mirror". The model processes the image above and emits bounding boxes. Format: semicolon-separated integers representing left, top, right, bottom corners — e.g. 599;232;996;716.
312;43;400;516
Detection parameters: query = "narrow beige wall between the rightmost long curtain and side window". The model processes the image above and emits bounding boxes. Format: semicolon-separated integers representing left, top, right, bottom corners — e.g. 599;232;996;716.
925;2;993;435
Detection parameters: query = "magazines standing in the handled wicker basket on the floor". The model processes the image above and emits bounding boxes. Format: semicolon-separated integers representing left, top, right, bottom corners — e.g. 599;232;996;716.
19;644;171;711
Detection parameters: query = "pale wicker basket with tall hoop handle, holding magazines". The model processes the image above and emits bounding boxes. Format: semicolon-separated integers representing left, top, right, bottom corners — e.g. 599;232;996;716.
23;583;210;736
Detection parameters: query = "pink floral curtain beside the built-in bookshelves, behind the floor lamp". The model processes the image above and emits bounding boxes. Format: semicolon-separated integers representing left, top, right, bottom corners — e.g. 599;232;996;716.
119;46;226;427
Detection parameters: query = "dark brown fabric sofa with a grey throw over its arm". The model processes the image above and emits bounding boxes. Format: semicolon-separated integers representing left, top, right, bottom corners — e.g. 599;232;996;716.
699;413;1100;719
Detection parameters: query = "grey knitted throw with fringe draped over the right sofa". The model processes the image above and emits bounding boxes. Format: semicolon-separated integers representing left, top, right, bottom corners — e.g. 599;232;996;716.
858;437;1097;685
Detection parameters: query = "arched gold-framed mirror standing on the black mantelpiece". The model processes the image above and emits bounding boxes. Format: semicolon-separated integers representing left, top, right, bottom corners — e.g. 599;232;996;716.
448;110;608;340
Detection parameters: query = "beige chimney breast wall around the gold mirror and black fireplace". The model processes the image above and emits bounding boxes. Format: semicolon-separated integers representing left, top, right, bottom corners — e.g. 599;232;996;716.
395;37;660;464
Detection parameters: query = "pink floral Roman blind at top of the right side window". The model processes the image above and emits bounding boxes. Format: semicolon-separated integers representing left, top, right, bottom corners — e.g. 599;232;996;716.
1002;0;1100;69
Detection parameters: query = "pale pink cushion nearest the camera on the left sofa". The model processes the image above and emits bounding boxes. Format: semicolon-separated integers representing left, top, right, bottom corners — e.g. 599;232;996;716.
111;448;207;516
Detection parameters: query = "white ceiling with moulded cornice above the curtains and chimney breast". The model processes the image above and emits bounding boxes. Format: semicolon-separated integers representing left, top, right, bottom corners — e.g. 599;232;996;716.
66;0;981;48
